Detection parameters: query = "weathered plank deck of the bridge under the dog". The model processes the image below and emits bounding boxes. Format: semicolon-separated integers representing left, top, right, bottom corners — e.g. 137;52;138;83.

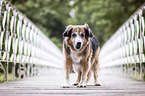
0;69;145;96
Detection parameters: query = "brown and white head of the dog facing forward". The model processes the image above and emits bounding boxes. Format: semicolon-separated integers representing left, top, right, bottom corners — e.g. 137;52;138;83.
63;24;93;50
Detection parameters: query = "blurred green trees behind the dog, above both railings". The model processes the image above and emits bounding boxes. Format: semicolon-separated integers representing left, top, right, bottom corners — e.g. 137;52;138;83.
9;0;144;49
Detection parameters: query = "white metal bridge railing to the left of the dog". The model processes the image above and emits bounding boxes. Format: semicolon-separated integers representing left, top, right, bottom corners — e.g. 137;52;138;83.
0;0;62;81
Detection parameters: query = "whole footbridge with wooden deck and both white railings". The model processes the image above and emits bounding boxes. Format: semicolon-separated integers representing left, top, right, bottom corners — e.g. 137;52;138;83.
0;0;145;96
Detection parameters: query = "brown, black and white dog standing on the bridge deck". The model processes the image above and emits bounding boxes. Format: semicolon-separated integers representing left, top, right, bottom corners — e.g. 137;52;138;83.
62;24;100;88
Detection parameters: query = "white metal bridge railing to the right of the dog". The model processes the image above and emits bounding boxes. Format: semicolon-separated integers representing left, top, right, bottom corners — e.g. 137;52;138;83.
100;3;145;79
